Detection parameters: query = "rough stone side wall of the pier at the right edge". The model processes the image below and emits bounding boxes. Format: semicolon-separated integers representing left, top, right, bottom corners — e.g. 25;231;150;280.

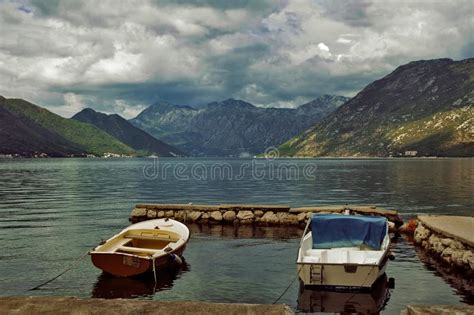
414;218;474;274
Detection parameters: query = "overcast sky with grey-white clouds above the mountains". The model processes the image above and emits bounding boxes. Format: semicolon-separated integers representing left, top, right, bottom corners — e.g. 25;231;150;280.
0;0;474;118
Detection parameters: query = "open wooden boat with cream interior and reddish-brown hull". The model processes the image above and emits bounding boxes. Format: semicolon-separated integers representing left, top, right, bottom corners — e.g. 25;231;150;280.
89;219;189;277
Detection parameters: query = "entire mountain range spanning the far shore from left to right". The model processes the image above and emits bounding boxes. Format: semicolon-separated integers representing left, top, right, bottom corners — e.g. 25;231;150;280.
0;58;474;157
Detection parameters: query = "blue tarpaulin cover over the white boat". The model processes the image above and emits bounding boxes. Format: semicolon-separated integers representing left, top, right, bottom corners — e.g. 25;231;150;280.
311;214;387;250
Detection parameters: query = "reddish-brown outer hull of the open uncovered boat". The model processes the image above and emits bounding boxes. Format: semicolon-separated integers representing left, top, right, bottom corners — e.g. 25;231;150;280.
91;246;185;277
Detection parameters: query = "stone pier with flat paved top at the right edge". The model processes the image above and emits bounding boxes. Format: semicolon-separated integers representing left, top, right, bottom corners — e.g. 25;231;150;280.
414;216;474;274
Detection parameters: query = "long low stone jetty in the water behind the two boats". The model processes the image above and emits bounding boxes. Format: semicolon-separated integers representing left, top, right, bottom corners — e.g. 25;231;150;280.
130;204;403;230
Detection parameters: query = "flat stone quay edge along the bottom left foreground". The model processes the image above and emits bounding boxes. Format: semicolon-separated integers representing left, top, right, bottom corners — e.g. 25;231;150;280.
0;296;294;315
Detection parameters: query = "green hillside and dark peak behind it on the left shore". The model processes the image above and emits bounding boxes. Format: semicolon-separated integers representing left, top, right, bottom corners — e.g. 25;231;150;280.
0;96;183;157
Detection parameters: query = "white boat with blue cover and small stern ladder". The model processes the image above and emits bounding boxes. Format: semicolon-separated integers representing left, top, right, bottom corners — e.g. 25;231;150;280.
296;214;391;290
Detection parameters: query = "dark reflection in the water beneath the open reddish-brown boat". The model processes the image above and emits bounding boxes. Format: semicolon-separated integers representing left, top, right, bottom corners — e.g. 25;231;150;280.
92;261;189;299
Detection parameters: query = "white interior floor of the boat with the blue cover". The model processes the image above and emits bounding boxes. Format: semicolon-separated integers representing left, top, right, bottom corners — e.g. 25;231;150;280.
302;247;384;264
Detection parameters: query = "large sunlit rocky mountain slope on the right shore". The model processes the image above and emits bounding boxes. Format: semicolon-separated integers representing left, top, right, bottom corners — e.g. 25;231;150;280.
279;58;474;156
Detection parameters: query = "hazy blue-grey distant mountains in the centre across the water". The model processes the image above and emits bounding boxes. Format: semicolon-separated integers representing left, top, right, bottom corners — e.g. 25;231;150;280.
130;95;348;156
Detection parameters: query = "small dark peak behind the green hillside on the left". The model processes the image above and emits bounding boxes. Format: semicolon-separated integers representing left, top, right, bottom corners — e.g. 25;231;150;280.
72;108;184;157
